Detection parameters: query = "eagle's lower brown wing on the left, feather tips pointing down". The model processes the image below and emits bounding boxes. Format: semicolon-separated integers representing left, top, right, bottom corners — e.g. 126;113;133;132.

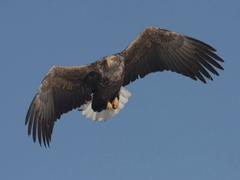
25;64;92;146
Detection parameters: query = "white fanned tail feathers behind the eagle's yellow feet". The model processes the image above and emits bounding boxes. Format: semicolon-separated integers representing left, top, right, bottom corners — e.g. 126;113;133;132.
78;87;132;122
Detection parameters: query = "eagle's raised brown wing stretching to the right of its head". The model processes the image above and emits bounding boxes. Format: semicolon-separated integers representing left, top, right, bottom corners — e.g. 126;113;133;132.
120;27;224;86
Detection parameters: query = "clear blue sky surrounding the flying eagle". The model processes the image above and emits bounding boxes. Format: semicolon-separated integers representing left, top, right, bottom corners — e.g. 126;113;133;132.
0;0;240;180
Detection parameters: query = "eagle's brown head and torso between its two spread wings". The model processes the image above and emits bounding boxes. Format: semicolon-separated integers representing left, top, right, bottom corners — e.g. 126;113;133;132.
80;54;124;112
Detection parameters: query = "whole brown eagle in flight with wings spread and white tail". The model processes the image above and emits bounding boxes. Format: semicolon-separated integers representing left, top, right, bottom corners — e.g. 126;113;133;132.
25;27;224;147
